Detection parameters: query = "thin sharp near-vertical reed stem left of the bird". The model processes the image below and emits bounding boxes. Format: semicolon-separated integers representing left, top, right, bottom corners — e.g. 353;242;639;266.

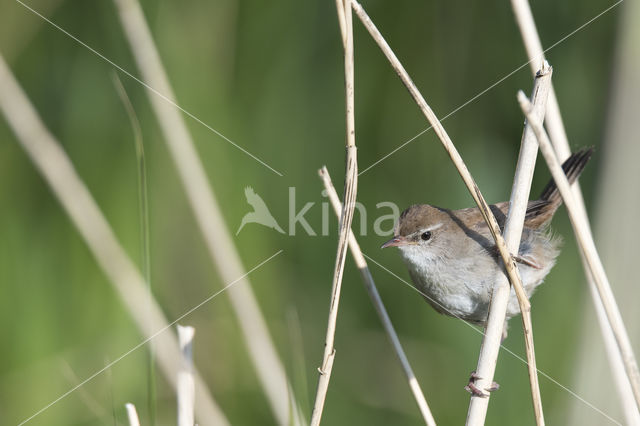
311;0;358;426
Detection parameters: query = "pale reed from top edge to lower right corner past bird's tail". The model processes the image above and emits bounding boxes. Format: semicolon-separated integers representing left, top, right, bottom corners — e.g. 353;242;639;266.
511;0;638;421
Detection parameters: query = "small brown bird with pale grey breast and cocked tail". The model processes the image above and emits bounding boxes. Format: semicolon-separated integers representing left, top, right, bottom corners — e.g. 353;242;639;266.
382;148;593;325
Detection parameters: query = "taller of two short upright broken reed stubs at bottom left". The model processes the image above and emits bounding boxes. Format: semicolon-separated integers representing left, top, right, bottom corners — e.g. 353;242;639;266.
176;325;196;426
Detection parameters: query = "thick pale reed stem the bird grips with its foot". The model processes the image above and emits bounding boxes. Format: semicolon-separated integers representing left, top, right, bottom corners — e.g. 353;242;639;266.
467;65;552;425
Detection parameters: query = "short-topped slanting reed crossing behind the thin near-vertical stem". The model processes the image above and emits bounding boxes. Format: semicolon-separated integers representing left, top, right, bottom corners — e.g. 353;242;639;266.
318;167;436;426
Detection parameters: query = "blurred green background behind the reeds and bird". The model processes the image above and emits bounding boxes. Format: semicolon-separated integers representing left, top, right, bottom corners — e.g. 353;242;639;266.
0;0;637;425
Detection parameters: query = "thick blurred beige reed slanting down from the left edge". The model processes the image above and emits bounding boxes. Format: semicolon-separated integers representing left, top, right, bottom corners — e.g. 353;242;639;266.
0;56;229;425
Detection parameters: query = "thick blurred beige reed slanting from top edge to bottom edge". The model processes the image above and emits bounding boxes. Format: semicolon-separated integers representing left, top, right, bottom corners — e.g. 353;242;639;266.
114;0;302;425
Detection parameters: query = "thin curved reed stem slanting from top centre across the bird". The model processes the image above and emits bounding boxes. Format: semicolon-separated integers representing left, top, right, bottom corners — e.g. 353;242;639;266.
352;0;541;422
